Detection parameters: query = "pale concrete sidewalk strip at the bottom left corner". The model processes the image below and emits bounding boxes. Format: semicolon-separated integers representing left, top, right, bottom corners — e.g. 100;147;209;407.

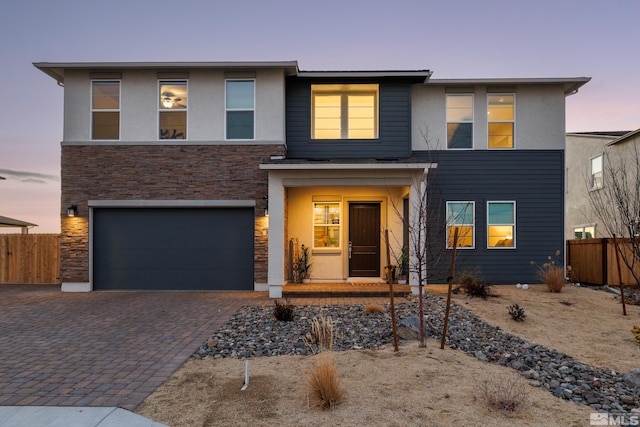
0;406;166;427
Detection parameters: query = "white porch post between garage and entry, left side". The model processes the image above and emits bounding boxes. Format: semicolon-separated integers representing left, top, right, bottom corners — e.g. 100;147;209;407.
267;171;285;298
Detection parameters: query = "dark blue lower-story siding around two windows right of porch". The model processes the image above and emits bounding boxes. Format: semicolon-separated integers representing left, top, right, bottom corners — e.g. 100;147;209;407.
413;150;564;284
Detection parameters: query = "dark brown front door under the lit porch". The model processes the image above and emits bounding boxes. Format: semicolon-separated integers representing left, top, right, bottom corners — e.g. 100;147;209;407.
349;203;380;277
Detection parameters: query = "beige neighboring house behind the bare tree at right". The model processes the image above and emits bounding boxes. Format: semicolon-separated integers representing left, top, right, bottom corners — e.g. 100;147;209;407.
566;129;640;239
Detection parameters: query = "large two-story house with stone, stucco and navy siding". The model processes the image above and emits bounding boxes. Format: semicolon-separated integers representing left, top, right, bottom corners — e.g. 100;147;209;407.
35;62;589;297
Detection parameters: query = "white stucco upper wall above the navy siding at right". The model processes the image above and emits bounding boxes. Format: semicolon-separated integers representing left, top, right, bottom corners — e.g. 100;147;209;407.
411;84;565;150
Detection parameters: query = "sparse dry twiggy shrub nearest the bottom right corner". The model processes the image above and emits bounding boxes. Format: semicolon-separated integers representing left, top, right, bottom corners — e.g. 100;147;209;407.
480;376;529;412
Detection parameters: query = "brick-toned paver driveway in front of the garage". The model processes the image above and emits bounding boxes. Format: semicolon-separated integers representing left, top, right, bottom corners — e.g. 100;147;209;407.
0;285;269;410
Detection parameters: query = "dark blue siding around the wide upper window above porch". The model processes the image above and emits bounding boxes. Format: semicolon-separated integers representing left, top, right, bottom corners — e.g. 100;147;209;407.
286;78;411;159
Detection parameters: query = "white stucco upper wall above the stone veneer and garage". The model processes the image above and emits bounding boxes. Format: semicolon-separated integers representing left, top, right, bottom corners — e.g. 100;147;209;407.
63;69;285;143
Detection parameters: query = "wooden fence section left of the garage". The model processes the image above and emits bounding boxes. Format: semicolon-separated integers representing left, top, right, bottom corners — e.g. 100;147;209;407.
0;234;60;283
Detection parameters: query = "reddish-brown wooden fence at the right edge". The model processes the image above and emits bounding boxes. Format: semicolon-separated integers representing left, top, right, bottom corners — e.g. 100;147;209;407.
567;238;640;285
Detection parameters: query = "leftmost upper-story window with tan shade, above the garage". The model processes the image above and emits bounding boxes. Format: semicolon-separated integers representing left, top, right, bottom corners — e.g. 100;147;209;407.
91;80;120;140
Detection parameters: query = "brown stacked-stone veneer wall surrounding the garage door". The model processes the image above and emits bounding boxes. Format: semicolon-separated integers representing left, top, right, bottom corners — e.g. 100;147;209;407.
60;144;285;283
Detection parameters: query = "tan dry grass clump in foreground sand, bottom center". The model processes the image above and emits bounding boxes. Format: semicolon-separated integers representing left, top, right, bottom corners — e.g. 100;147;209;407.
307;355;344;409
